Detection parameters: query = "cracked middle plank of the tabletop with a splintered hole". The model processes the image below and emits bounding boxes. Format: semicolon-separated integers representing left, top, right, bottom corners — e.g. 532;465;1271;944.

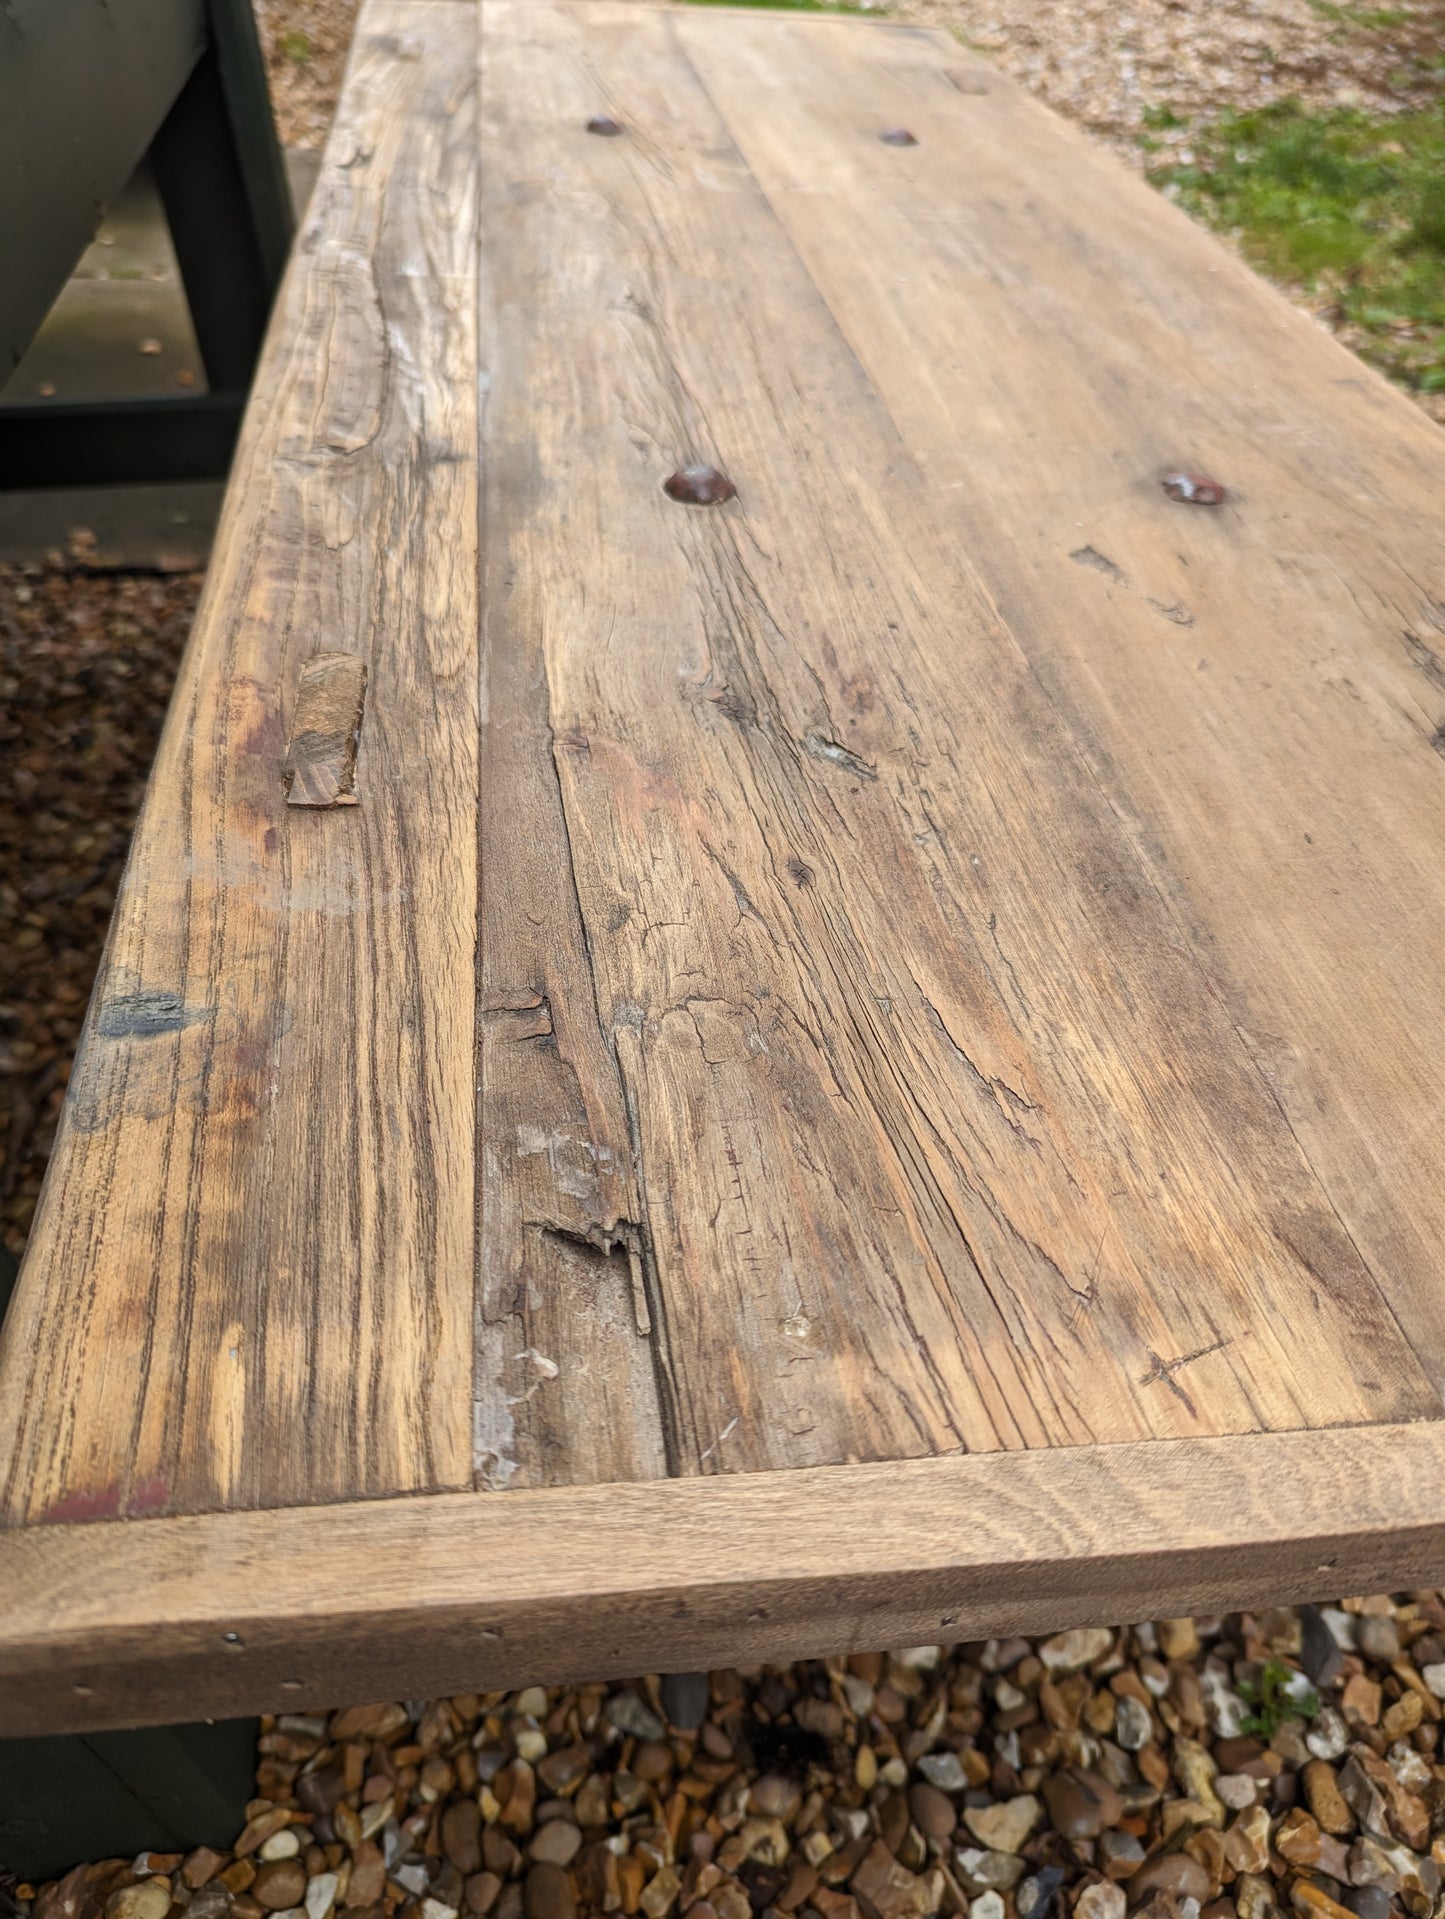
478;0;1439;1485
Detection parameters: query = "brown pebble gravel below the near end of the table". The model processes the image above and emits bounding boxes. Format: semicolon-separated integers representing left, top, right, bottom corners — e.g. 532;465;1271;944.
8;1593;1445;1919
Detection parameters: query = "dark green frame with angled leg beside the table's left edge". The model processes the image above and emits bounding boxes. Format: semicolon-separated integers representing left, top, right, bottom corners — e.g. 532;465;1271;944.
0;0;296;489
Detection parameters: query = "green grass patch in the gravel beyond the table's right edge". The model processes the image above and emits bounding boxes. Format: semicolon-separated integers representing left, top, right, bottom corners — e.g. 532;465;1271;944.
1142;102;1445;393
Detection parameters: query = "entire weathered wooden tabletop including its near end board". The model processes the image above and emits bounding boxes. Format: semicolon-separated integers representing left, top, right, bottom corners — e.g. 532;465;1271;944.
0;0;1445;1733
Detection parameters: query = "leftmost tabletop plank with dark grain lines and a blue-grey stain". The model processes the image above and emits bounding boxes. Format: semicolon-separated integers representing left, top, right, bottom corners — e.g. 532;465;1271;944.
0;0;478;1524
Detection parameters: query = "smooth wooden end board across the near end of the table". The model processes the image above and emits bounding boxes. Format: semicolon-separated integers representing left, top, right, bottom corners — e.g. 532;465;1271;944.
0;1424;1445;1735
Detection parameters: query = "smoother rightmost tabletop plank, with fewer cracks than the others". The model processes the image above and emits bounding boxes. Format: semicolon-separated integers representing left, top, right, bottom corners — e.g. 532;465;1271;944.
679;3;1445;1412
